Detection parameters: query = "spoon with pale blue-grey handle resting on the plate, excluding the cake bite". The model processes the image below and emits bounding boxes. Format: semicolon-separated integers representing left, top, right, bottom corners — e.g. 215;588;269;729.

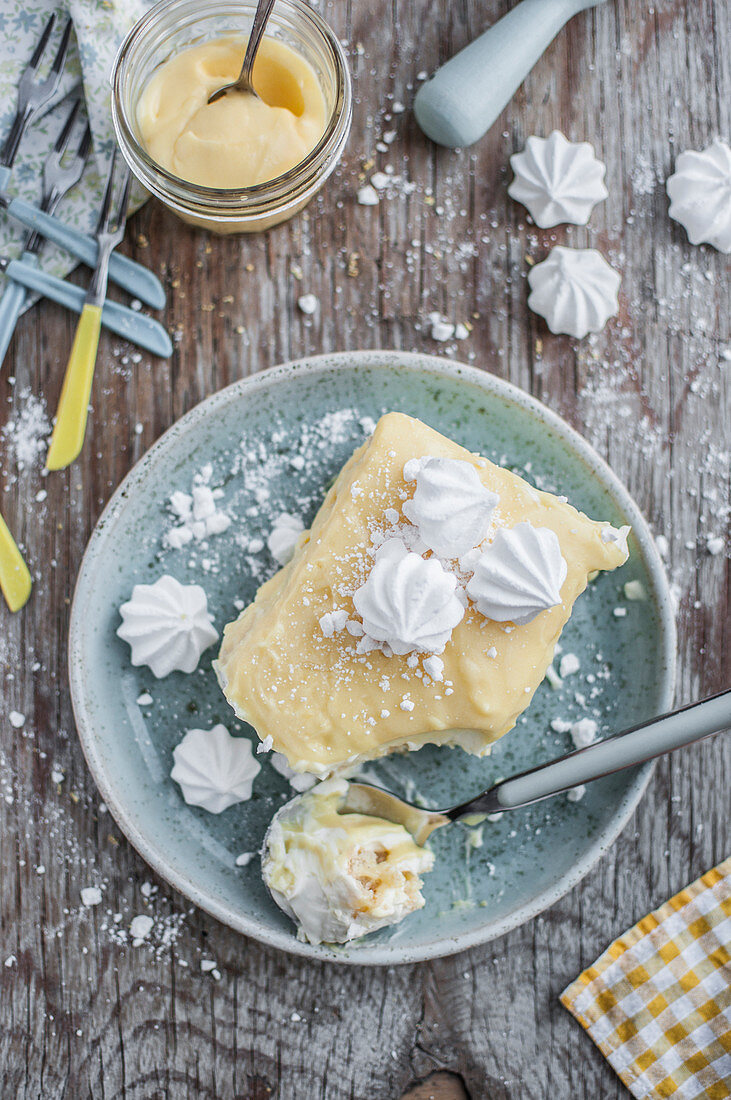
340;691;731;845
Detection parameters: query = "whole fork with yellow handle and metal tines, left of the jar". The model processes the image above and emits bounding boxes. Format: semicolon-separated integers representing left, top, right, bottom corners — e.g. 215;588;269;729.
46;149;132;470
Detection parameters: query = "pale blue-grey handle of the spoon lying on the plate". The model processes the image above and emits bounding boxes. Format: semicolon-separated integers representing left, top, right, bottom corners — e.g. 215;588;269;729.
492;691;731;810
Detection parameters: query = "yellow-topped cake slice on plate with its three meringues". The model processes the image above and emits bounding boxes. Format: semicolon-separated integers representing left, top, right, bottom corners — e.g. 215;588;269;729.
215;413;628;778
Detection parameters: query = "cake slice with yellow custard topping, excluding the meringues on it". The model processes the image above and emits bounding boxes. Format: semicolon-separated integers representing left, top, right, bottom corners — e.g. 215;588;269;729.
217;413;627;776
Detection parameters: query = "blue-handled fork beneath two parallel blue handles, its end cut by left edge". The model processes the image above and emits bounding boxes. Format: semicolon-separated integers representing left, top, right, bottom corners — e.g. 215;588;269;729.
0;98;91;363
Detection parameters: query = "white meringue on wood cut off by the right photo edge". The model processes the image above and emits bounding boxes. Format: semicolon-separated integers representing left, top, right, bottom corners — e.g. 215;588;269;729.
665;138;731;253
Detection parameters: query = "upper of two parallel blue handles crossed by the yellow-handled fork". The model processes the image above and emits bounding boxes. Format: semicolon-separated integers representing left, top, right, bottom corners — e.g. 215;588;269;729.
8;199;165;309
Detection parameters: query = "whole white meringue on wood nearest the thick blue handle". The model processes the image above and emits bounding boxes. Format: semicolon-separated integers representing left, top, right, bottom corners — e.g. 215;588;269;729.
508;130;609;229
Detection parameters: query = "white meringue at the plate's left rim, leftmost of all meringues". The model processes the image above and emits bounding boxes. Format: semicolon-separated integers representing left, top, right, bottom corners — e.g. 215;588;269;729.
117;573;219;680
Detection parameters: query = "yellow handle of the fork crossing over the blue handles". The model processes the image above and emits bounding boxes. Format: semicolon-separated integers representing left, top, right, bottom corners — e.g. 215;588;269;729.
46;305;101;470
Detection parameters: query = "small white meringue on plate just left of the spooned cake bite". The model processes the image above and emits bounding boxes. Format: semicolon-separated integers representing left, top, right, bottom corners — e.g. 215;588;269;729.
170;725;262;814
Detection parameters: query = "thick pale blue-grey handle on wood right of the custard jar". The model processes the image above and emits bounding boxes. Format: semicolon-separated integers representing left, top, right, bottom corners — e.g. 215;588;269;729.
413;0;605;149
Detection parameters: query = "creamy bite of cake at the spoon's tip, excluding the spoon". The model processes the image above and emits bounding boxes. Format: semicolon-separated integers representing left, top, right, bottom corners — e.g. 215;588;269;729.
262;780;434;944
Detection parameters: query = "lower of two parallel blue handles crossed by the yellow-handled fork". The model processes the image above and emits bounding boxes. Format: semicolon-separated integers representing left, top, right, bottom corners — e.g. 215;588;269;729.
5;260;173;359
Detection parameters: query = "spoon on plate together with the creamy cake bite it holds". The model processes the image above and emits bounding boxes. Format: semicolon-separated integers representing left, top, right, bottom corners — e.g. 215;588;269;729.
262;691;731;943
